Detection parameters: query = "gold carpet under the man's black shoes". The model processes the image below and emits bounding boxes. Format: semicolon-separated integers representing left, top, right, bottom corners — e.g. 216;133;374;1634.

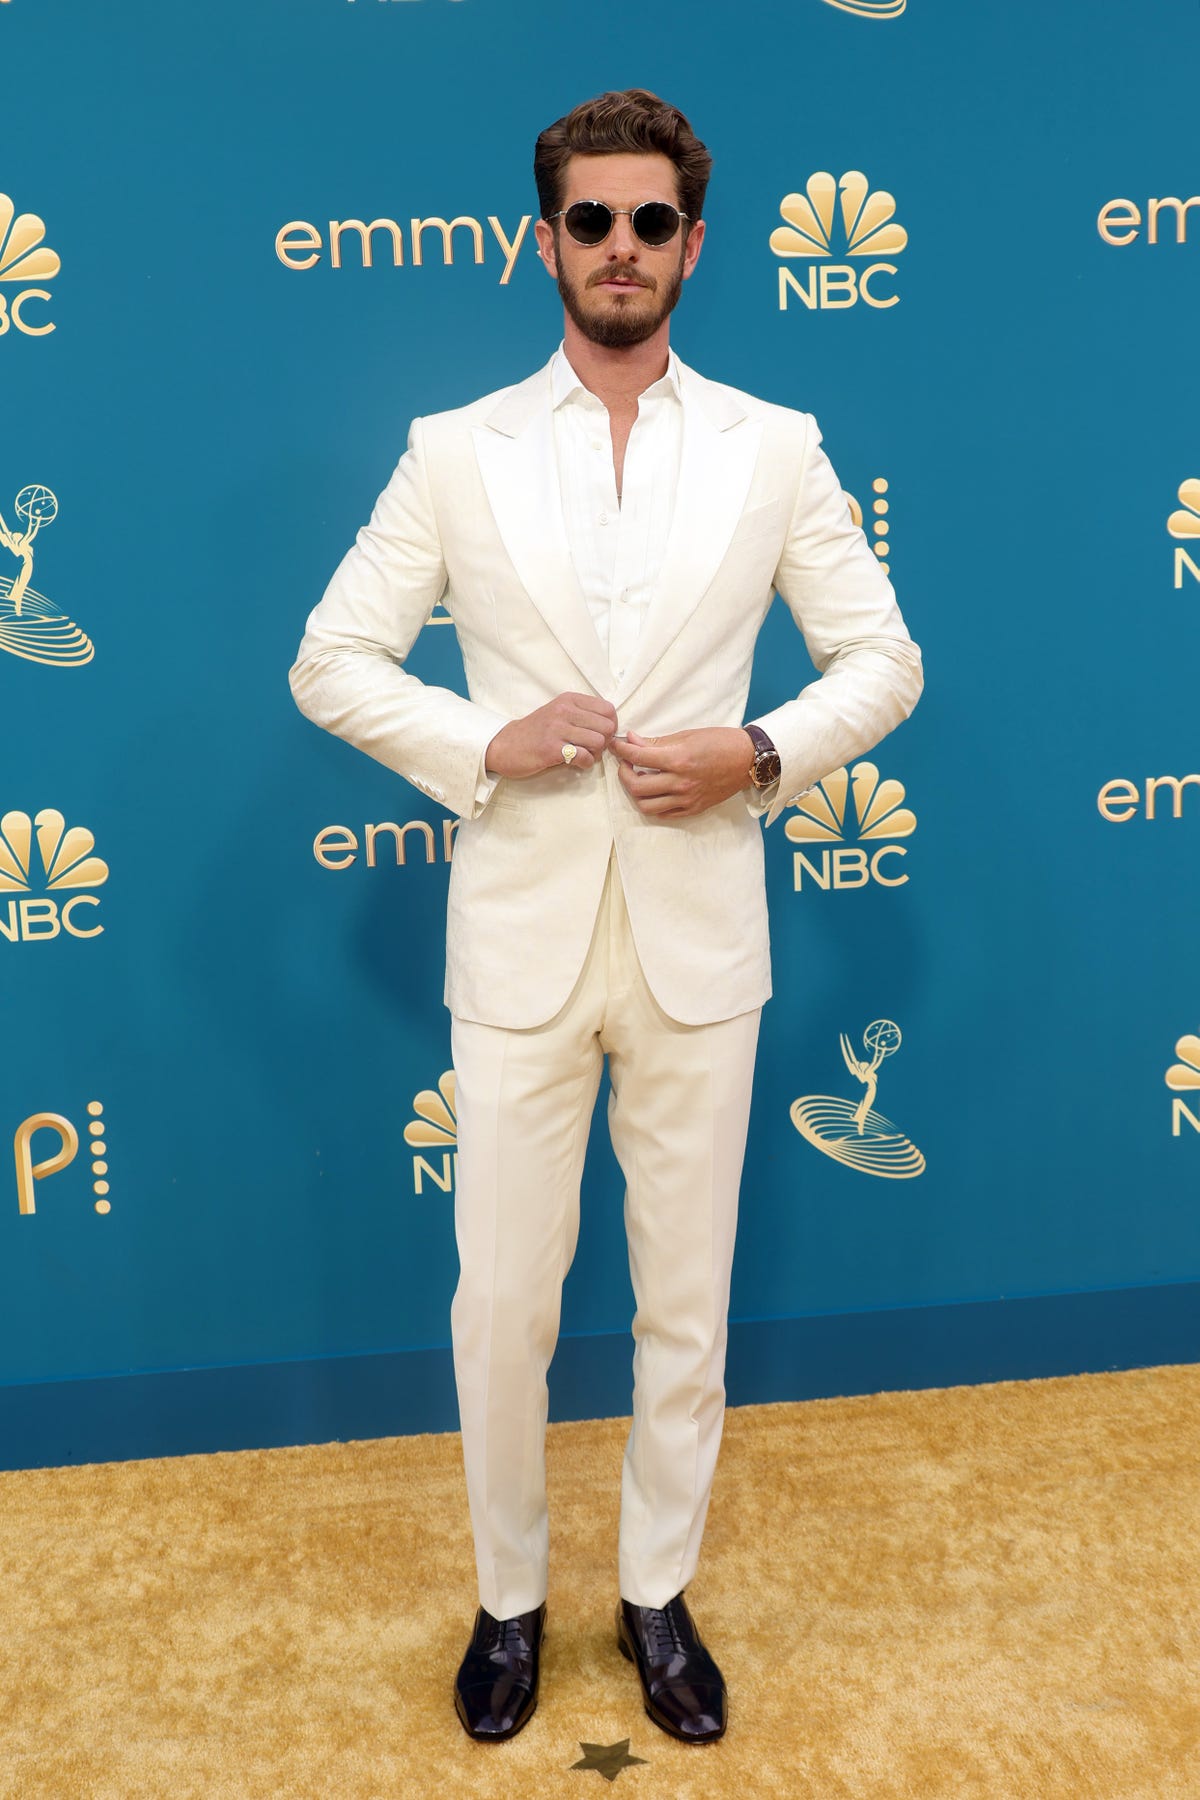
0;1366;1200;1800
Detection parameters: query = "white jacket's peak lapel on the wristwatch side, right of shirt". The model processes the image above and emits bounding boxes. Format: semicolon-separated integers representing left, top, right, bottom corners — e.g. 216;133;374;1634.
615;364;763;706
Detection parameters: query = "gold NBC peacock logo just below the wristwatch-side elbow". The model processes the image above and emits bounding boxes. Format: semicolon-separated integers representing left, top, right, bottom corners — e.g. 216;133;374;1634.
784;763;918;893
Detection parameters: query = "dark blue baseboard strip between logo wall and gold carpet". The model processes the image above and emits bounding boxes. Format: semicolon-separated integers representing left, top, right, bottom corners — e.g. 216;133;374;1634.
0;1282;1200;1469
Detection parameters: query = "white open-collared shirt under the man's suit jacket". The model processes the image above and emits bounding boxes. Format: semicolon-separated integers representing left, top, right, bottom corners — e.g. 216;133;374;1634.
551;344;684;680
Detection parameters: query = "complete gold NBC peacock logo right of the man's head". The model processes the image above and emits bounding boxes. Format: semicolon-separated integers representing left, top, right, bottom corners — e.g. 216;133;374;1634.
770;169;909;313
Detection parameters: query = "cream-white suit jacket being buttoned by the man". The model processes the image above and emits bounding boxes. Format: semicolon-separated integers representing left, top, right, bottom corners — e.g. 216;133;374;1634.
291;352;921;1028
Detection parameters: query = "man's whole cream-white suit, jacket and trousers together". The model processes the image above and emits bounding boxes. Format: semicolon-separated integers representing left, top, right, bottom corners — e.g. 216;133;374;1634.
291;351;921;1618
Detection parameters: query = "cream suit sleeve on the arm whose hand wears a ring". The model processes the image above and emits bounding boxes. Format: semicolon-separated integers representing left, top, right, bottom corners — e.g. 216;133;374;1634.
288;419;507;819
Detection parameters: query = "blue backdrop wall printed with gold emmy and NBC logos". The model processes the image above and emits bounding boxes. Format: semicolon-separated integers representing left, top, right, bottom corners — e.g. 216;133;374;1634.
0;0;1200;1461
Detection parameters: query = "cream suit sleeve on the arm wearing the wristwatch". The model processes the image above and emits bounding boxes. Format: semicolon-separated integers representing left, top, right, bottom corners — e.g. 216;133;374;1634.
752;418;923;824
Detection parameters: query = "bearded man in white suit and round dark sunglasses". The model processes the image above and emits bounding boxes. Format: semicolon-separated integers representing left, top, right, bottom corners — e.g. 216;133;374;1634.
291;88;921;1742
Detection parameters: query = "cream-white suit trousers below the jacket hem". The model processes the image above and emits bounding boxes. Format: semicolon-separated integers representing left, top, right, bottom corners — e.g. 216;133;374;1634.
452;860;759;1618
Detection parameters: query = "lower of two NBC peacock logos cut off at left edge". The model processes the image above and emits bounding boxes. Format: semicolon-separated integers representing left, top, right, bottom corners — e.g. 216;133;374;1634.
0;806;108;943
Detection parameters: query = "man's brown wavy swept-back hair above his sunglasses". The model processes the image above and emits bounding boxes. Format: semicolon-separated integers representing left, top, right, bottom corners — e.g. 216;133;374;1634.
533;88;712;225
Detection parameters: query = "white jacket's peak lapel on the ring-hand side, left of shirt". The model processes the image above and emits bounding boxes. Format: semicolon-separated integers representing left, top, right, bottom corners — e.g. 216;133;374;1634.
471;369;613;695
